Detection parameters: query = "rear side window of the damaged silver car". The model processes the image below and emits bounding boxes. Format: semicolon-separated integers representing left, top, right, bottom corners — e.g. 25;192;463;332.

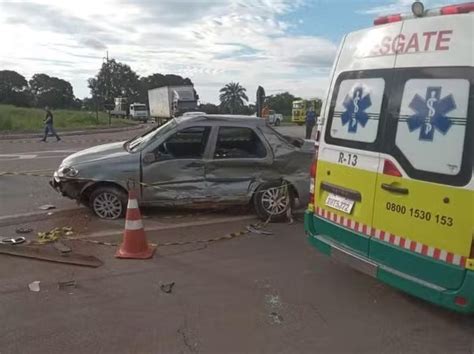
214;127;267;159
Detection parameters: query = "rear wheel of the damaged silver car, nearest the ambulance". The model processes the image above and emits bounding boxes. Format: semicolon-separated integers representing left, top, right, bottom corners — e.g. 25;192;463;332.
253;181;295;221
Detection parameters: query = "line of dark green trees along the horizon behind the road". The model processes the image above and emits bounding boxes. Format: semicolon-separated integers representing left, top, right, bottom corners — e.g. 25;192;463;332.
0;59;297;115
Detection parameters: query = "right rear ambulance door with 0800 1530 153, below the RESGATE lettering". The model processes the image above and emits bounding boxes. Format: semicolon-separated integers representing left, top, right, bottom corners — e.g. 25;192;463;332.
370;67;474;289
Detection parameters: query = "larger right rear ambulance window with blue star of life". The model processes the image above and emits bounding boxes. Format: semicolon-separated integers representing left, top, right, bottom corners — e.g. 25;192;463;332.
395;78;470;176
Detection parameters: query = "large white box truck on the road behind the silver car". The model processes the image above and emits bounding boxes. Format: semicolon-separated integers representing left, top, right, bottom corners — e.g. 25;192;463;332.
148;85;197;124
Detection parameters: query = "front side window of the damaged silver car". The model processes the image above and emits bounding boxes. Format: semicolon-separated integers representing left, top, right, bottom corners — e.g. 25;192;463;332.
158;127;211;159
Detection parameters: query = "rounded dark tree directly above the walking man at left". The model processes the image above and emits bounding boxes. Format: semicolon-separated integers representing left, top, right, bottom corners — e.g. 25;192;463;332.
30;74;75;108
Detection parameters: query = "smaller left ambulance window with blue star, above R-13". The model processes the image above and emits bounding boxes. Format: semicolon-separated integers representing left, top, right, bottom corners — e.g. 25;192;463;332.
330;78;385;143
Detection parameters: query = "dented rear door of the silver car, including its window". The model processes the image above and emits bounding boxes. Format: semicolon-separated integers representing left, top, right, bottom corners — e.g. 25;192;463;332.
206;125;273;204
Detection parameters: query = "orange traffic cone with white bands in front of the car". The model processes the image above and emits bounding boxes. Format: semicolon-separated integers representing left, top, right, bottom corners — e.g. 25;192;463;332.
115;190;155;259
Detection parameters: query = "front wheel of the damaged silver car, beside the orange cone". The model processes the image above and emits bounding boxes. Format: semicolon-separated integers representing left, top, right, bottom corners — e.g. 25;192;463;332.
89;186;128;220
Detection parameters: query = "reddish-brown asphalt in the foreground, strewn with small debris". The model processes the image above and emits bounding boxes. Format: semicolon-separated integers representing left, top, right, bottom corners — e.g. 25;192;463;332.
0;221;474;354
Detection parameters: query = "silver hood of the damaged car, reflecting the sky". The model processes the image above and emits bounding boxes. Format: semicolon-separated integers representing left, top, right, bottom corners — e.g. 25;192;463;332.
62;141;130;166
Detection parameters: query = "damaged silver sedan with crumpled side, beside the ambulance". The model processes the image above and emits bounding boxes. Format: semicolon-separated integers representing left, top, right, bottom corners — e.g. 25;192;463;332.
50;115;314;219
